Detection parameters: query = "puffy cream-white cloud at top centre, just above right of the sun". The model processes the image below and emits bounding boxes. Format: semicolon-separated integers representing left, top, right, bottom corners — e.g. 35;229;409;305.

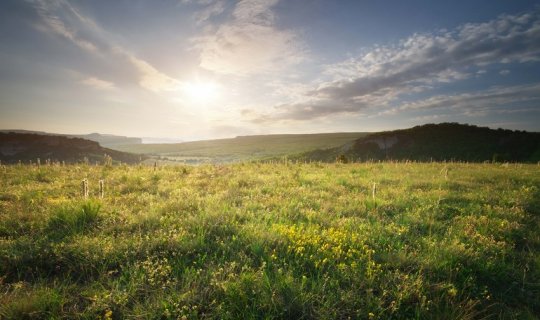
194;0;305;75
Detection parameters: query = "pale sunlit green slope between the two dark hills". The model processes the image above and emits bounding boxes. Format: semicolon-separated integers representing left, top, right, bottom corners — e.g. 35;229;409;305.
113;132;366;160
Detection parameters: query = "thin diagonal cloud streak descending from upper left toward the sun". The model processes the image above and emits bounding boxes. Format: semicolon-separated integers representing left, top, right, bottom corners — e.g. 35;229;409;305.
27;0;179;93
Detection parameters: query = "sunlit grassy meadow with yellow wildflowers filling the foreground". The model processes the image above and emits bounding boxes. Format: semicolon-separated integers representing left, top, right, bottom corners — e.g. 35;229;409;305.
0;163;540;319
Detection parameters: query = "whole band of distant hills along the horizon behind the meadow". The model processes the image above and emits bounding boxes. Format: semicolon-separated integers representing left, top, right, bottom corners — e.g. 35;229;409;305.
0;123;540;164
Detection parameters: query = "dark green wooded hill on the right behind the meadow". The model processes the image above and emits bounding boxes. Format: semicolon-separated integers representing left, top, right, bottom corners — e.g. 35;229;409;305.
297;123;540;162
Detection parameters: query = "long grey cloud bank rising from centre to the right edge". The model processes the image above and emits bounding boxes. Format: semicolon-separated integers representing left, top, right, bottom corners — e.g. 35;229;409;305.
255;12;540;121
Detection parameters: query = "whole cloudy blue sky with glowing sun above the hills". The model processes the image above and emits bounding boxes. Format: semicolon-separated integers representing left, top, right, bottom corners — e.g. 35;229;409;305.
0;0;540;140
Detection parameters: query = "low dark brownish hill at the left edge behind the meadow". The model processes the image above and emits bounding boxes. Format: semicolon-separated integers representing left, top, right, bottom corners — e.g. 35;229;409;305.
0;132;141;163
